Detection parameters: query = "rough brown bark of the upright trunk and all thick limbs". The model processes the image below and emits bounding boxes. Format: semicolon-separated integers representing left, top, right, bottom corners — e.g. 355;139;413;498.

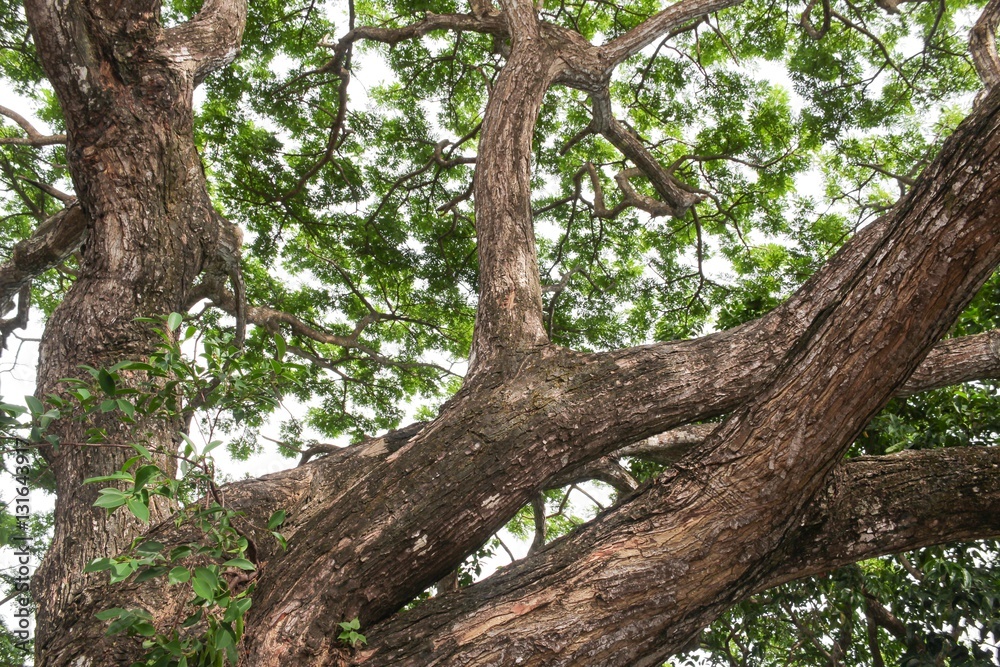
13;0;1000;667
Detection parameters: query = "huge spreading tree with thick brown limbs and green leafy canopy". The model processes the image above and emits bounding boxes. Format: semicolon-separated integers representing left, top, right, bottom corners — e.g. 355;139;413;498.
0;0;1000;666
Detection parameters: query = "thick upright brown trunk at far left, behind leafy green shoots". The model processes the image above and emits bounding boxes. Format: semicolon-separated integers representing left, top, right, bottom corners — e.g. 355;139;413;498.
26;1;242;664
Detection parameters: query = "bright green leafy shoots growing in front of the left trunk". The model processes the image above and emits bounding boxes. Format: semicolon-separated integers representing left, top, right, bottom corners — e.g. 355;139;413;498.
0;320;294;667
